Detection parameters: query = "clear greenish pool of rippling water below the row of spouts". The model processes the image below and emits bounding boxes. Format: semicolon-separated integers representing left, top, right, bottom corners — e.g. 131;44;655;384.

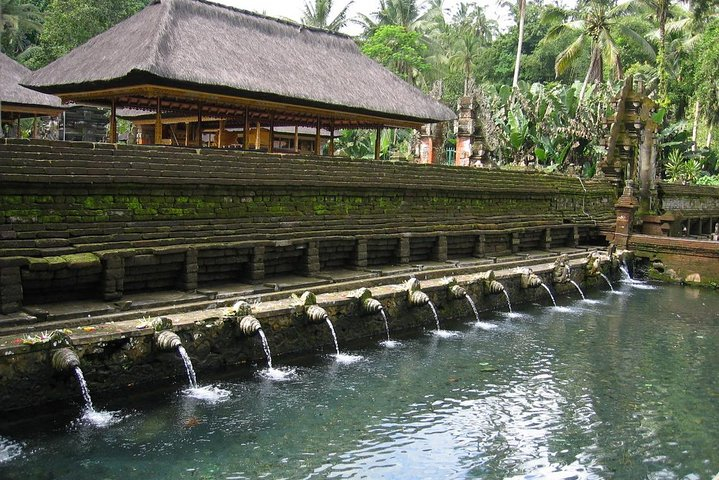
0;284;719;480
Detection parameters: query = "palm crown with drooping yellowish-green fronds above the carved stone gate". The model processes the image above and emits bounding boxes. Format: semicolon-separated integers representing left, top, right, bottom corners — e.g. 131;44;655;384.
544;2;654;101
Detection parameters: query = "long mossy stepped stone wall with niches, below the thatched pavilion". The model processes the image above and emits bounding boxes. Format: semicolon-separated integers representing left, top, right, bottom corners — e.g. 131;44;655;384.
0;140;616;313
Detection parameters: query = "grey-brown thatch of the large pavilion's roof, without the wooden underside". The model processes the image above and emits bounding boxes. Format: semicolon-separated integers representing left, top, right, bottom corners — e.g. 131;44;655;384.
27;0;455;123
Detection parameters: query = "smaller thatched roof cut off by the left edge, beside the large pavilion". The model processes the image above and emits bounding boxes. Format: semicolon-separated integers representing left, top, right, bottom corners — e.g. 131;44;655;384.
0;53;63;133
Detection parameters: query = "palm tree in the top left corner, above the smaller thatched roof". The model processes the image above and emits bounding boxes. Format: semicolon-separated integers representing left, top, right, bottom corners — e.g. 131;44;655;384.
0;0;42;56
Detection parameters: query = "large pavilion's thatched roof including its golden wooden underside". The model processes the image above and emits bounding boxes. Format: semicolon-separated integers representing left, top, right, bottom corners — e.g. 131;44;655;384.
27;0;455;154
